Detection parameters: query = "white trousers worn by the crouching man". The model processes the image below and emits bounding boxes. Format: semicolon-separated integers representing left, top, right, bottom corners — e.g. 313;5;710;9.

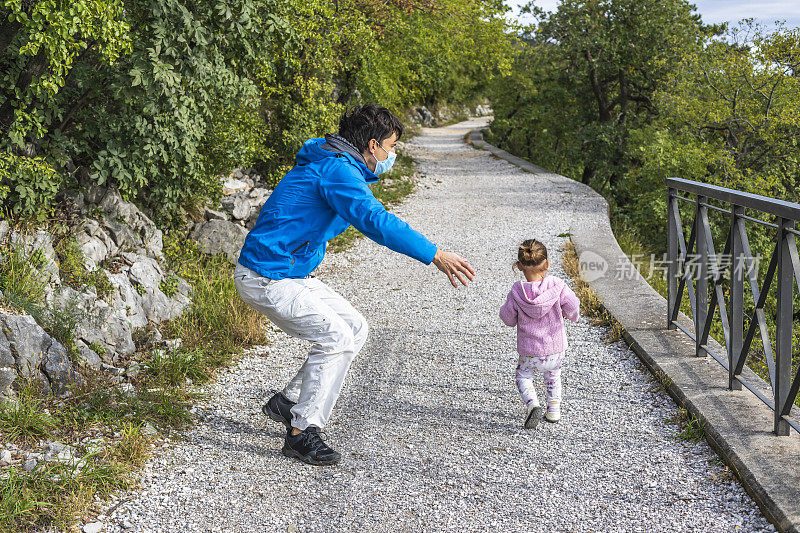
233;264;368;430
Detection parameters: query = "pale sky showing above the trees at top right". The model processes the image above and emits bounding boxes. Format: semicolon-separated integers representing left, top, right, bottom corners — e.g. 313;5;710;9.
506;0;800;27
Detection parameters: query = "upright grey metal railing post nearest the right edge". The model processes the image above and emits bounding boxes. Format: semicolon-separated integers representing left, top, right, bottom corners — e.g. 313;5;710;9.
775;218;794;435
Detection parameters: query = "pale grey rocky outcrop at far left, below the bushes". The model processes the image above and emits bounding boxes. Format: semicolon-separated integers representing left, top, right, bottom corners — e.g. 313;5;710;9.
0;185;192;394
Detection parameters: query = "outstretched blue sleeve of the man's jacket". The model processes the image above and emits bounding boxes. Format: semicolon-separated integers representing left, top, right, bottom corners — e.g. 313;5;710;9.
320;162;437;265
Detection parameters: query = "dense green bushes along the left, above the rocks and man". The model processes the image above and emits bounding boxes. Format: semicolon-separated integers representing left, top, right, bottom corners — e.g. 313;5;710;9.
0;0;512;223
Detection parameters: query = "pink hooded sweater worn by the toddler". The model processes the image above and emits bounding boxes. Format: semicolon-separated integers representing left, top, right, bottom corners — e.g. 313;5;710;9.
500;276;581;356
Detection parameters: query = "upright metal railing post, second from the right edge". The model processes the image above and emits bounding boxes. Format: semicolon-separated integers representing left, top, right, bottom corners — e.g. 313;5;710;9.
728;205;745;390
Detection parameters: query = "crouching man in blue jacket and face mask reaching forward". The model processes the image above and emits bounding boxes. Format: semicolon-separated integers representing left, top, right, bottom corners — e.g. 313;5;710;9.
234;104;475;465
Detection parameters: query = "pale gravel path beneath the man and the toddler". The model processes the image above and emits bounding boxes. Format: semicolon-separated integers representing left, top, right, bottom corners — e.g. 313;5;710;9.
104;119;774;532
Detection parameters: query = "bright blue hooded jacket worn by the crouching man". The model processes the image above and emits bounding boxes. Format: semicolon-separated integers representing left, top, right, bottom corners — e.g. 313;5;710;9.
239;138;436;279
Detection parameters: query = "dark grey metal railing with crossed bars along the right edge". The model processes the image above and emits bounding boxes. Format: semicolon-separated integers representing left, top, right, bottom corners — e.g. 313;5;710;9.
667;178;800;435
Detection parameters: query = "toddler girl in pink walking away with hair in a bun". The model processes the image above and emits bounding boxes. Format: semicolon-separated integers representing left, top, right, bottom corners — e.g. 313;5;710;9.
500;239;580;429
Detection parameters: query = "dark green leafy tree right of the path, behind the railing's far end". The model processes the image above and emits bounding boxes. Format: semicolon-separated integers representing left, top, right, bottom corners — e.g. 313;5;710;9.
492;0;702;189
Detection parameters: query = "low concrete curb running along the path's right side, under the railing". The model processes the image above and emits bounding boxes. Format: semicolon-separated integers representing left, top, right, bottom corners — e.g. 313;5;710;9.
468;131;800;532
